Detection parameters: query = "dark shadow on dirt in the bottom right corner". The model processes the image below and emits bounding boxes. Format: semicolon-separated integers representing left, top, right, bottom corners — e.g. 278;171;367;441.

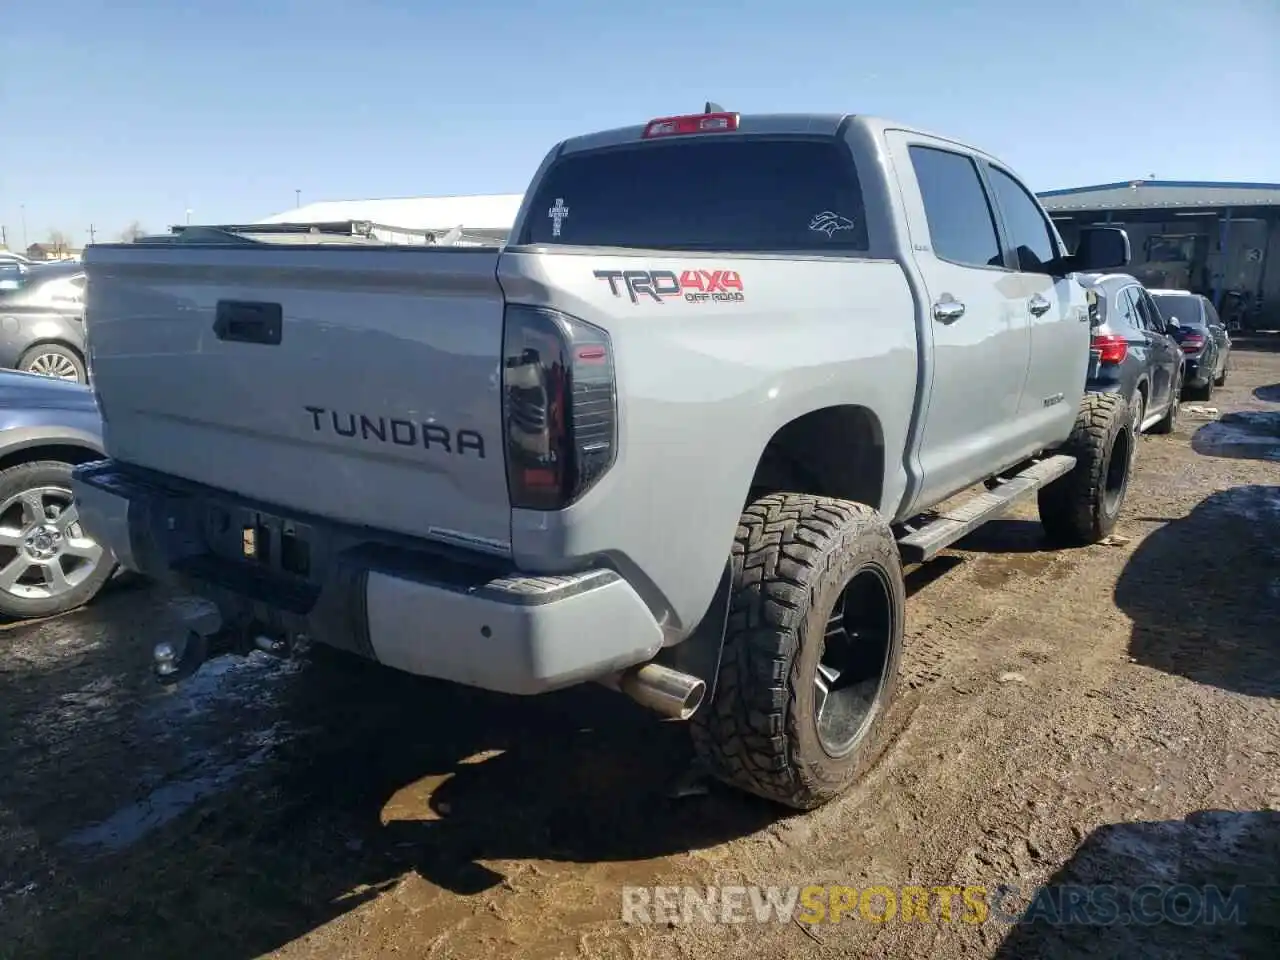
996;810;1280;960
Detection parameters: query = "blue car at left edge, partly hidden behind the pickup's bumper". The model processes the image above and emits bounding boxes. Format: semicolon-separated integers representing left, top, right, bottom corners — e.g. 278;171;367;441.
0;370;115;620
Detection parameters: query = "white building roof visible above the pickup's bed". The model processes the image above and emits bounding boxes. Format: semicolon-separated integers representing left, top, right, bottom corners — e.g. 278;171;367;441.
257;193;525;230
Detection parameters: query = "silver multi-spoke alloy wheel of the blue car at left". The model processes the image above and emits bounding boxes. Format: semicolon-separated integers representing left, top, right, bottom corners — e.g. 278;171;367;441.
0;461;115;620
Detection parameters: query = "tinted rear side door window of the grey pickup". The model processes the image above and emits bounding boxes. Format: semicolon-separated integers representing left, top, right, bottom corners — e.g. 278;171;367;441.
909;146;1005;266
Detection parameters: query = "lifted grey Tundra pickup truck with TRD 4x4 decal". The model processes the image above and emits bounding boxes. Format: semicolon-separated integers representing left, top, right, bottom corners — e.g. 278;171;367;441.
76;105;1134;808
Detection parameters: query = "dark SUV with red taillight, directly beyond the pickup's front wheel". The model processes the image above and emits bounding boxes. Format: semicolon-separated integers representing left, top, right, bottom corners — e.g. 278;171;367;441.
1079;274;1184;434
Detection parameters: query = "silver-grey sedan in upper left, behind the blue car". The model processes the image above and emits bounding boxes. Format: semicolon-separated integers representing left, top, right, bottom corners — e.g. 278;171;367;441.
0;262;88;383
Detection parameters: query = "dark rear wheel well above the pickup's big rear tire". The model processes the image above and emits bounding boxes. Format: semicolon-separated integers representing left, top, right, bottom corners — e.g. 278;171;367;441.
750;406;884;509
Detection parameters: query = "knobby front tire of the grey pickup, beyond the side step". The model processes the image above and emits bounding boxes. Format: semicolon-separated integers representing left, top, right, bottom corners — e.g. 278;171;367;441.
1038;393;1137;547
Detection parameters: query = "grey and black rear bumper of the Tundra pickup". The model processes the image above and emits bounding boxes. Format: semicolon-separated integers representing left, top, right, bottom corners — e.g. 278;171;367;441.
73;461;662;694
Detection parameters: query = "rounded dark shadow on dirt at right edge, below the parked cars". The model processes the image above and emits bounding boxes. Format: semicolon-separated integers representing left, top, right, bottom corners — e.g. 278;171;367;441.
1115;485;1280;696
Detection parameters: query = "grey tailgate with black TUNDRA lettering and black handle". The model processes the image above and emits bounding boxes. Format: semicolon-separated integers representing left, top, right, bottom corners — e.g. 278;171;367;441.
84;244;511;553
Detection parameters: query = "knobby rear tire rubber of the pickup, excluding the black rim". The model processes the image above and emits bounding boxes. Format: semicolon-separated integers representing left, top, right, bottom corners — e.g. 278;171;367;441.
691;493;906;810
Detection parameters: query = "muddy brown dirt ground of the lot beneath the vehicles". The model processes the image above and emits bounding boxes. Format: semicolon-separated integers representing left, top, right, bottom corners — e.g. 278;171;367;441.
0;340;1280;960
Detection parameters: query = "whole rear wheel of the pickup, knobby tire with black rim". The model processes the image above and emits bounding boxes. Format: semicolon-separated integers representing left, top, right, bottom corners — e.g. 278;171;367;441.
691;493;906;810
